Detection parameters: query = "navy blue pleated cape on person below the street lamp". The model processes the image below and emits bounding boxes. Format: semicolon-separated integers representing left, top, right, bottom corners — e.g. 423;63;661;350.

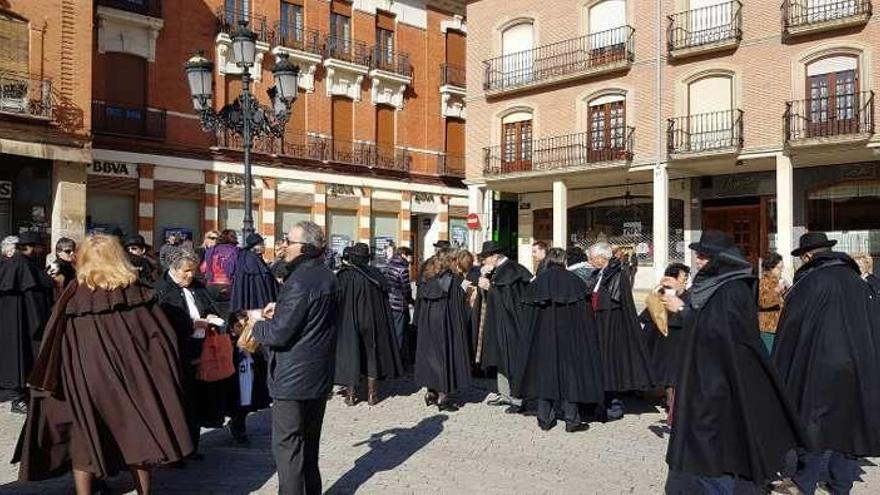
229;249;278;313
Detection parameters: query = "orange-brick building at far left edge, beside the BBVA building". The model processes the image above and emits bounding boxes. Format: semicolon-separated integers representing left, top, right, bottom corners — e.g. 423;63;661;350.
0;0;92;248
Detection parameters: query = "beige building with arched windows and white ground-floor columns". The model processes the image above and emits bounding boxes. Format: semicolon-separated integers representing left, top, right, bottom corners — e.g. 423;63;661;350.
467;0;880;286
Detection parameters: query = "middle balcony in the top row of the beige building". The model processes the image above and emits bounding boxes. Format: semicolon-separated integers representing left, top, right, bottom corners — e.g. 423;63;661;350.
666;0;742;58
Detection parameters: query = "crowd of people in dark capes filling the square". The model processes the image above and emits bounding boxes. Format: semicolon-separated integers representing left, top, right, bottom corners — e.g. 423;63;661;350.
0;222;880;494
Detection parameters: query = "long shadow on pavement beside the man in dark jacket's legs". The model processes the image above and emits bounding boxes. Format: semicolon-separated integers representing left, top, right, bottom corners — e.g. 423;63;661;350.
325;414;449;494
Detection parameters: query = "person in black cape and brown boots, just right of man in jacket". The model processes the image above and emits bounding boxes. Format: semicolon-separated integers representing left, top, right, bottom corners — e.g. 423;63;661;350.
335;243;403;406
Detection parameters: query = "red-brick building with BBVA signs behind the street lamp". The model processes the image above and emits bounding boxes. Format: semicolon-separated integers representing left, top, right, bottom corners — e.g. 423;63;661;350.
87;0;468;264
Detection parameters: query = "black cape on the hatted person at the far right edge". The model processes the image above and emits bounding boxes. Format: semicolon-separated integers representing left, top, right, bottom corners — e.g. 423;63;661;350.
773;252;880;457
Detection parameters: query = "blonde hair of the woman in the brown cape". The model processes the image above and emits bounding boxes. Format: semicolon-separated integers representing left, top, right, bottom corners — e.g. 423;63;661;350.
76;234;137;290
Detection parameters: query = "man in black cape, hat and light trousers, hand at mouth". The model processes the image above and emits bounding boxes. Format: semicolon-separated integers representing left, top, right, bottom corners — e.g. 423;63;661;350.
478;241;532;413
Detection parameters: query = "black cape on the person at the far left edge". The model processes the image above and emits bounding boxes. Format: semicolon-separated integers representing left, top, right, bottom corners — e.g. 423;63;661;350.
0;254;54;389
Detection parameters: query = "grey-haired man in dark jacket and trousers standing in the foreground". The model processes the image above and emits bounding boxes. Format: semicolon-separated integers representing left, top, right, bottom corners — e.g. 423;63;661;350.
250;222;339;495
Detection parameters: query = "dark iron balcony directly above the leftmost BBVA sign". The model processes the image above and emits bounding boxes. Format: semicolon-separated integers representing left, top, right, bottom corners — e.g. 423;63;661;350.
92;100;166;140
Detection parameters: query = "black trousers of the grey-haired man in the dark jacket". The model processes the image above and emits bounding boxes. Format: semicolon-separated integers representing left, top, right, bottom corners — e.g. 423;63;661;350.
272;398;327;495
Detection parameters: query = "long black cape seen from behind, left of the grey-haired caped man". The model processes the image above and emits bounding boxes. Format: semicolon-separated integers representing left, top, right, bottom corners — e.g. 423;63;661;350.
514;264;605;403
